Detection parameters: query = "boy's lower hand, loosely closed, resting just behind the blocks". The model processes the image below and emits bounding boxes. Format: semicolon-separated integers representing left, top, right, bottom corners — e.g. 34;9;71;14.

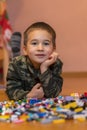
27;83;44;98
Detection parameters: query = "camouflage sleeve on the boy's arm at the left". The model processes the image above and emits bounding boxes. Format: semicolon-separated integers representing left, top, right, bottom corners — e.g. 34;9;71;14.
6;62;28;100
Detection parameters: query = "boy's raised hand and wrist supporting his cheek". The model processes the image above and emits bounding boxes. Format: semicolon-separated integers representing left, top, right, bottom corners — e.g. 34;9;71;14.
40;52;58;73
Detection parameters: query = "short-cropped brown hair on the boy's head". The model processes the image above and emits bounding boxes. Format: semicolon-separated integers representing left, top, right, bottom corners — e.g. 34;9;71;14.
24;22;56;48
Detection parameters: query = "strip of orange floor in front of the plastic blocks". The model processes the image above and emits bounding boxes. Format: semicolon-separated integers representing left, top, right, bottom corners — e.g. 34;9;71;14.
0;121;87;130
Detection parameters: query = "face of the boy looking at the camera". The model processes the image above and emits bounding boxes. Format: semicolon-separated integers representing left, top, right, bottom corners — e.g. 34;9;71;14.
24;29;54;68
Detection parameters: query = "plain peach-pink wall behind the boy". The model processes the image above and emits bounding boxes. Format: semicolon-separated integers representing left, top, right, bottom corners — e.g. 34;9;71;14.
7;0;87;72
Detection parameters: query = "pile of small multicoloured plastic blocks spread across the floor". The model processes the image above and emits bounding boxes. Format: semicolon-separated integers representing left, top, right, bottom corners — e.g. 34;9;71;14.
0;92;87;124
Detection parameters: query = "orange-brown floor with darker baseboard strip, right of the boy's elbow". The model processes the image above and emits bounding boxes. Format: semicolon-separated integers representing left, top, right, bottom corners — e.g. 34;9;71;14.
61;72;87;95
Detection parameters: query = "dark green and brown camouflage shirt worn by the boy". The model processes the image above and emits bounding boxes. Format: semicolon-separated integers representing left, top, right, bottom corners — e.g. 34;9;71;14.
6;56;63;100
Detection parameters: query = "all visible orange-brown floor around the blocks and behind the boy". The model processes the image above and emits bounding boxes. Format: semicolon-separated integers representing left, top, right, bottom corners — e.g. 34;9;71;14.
0;73;87;130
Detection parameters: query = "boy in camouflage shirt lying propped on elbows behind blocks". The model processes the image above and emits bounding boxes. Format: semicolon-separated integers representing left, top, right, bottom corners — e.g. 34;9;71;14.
6;22;63;100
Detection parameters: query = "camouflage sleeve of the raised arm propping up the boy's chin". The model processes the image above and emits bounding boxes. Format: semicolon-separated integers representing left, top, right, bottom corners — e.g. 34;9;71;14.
39;60;63;98
